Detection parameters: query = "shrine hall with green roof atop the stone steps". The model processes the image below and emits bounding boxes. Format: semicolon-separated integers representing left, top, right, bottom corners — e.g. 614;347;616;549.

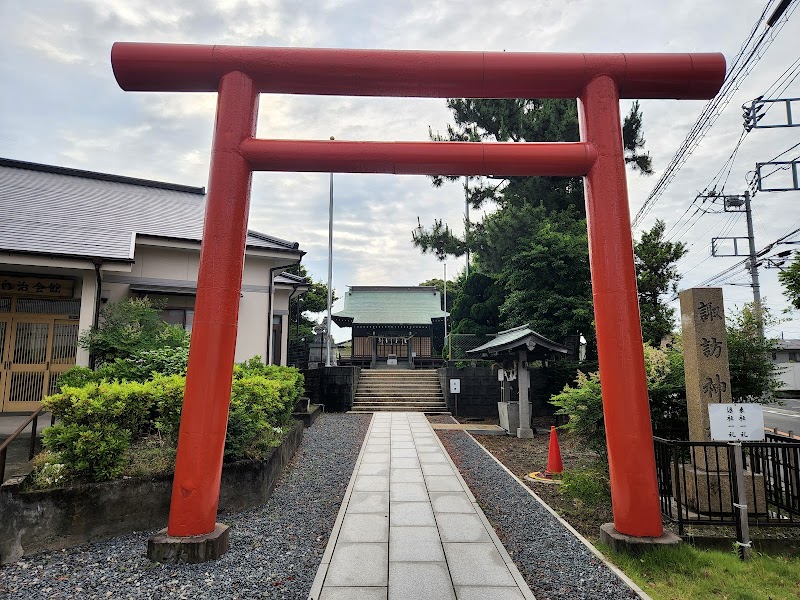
332;286;447;367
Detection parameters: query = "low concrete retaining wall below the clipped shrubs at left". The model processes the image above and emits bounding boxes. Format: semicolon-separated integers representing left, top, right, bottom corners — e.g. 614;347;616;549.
0;422;303;564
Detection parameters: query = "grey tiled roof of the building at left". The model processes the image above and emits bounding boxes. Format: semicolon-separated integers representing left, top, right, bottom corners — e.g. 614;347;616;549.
0;158;301;260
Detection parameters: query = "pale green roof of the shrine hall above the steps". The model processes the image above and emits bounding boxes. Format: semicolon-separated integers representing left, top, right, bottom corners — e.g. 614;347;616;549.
332;286;448;327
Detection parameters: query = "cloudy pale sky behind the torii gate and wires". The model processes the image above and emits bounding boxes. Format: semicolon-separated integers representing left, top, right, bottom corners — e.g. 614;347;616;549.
0;0;800;337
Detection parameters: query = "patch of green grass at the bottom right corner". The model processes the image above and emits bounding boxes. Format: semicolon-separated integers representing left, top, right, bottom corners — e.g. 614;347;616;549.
598;544;800;600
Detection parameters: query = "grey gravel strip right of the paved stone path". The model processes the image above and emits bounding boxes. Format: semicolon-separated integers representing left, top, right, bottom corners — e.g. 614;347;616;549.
436;430;637;600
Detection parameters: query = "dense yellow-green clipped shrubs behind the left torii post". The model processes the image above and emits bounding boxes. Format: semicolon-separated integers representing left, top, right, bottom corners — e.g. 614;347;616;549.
38;351;303;481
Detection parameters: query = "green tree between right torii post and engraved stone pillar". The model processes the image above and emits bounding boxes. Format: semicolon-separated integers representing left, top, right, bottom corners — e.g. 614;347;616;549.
633;219;688;346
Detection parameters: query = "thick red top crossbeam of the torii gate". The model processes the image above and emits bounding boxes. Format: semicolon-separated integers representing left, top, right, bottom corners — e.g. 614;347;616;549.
111;42;725;100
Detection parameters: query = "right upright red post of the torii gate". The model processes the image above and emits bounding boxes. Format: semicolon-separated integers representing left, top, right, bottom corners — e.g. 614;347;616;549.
578;75;663;537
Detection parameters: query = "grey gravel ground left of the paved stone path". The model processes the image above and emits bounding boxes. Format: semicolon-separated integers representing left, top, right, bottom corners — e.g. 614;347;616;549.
0;414;371;599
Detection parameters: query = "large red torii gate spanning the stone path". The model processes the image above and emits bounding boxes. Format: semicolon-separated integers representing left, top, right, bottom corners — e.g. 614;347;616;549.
111;42;725;548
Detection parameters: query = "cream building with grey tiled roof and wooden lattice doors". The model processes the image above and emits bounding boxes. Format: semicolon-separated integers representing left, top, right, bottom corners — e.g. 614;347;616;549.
0;159;308;412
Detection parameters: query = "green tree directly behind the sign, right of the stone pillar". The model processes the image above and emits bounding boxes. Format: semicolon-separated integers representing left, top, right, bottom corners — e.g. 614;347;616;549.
727;303;781;403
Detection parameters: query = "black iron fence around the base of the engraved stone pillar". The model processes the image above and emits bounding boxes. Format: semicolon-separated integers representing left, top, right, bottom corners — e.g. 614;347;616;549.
654;434;800;534
